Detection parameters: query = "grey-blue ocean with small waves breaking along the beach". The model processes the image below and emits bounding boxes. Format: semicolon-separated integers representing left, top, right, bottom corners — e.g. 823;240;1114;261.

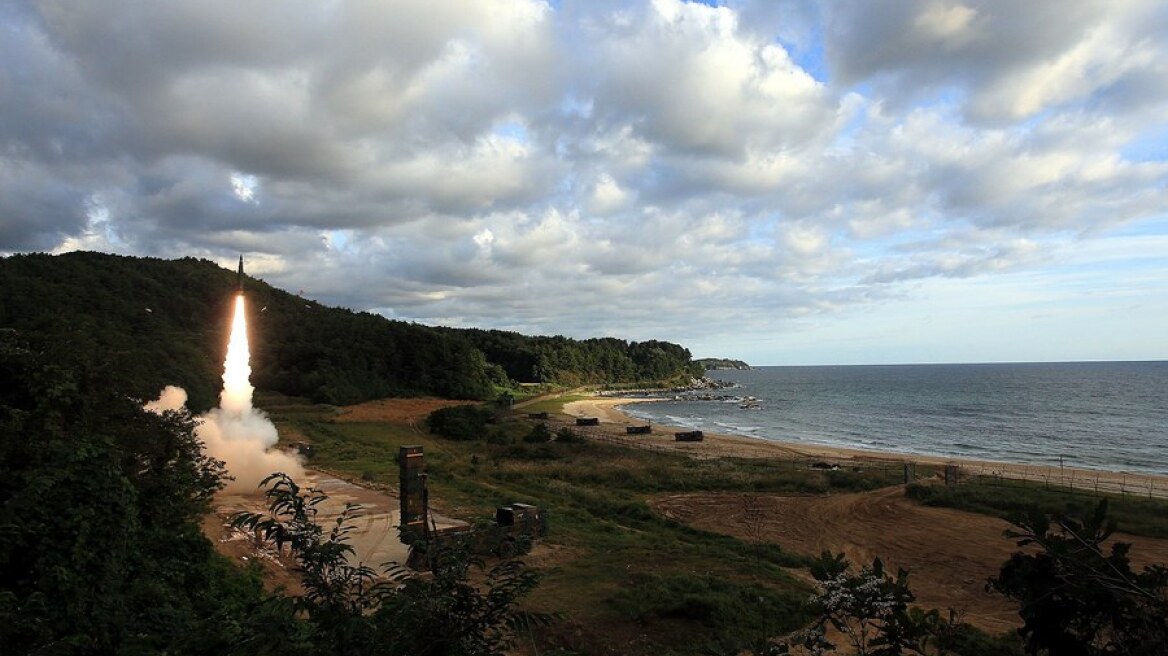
621;361;1168;475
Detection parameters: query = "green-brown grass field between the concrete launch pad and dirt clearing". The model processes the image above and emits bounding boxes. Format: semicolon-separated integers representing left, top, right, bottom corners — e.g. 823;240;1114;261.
265;396;1051;655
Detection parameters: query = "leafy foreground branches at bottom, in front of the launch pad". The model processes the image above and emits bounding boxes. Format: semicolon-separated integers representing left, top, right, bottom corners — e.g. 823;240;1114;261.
232;473;548;656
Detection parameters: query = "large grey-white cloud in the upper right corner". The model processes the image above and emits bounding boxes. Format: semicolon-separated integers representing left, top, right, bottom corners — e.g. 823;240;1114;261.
827;0;1168;123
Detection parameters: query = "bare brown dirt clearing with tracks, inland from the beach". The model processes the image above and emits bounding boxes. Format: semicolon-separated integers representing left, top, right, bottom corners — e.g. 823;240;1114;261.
653;487;1168;633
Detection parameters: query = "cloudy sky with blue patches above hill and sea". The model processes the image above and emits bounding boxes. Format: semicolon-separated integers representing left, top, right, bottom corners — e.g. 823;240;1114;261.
0;0;1168;364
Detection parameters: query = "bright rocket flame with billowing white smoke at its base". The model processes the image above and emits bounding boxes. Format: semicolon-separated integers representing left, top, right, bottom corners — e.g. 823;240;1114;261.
146;285;304;493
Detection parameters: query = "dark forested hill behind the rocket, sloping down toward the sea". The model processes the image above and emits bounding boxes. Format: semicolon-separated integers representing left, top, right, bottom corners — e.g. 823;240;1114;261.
0;252;701;411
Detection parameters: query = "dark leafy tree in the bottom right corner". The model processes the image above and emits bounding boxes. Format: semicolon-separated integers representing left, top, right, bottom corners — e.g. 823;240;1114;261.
988;498;1168;656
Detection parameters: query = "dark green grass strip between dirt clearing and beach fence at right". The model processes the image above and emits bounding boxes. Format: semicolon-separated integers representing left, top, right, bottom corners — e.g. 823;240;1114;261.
905;476;1168;538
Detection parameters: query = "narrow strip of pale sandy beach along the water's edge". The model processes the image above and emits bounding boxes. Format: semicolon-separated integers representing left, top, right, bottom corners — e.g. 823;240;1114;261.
563;396;1168;498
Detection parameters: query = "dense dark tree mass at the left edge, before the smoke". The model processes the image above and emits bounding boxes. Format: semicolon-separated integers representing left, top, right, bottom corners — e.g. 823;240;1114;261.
0;332;279;654
